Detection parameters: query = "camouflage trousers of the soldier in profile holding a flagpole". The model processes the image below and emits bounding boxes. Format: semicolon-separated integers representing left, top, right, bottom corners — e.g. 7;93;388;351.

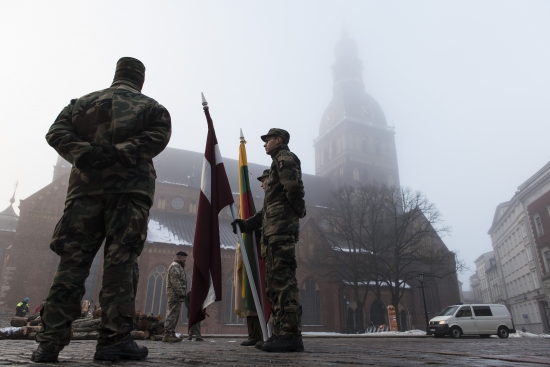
264;238;302;336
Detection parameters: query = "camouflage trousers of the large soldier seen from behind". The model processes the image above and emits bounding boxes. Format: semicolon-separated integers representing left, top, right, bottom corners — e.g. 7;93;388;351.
36;194;150;351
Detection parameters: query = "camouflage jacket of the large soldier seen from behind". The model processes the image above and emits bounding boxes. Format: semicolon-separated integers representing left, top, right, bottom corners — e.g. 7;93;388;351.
46;81;171;203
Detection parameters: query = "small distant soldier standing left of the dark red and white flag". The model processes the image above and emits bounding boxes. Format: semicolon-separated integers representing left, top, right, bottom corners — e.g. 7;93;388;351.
162;251;187;343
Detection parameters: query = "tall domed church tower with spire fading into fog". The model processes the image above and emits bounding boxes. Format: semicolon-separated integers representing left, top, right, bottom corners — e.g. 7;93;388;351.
314;29;399;186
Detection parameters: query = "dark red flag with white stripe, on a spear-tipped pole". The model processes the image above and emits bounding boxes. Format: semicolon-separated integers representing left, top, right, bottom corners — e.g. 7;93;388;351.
189;96;234;327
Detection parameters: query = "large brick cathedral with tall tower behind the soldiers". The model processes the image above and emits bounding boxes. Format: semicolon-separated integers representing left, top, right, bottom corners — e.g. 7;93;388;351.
0;32;460;334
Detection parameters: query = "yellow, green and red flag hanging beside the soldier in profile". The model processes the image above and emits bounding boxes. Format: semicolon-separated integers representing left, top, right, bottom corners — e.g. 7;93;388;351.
234;138;271;320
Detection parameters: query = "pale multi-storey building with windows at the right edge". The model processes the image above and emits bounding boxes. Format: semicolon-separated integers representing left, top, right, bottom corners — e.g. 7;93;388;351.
488;164;550;334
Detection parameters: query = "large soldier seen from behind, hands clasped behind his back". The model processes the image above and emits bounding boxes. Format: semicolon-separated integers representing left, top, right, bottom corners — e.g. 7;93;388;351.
31;57;171;362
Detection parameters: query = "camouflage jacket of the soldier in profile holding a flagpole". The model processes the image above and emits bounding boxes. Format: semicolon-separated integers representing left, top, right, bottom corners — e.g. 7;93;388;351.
245;144;306;245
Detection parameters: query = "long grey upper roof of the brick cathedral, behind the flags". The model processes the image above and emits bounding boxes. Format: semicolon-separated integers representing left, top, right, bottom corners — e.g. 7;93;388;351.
153;148;335;206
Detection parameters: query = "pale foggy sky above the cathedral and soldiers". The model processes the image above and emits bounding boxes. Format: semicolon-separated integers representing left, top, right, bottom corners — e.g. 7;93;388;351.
0;0;550;290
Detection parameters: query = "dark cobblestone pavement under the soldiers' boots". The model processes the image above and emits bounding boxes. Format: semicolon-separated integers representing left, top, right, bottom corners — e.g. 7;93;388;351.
0;336;550;367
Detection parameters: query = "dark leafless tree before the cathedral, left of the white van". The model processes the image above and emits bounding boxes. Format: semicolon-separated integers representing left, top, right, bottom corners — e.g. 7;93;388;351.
318;184;463;330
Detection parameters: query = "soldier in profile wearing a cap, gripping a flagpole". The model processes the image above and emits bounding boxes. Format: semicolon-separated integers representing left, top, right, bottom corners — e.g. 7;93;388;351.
232;129;306;352
